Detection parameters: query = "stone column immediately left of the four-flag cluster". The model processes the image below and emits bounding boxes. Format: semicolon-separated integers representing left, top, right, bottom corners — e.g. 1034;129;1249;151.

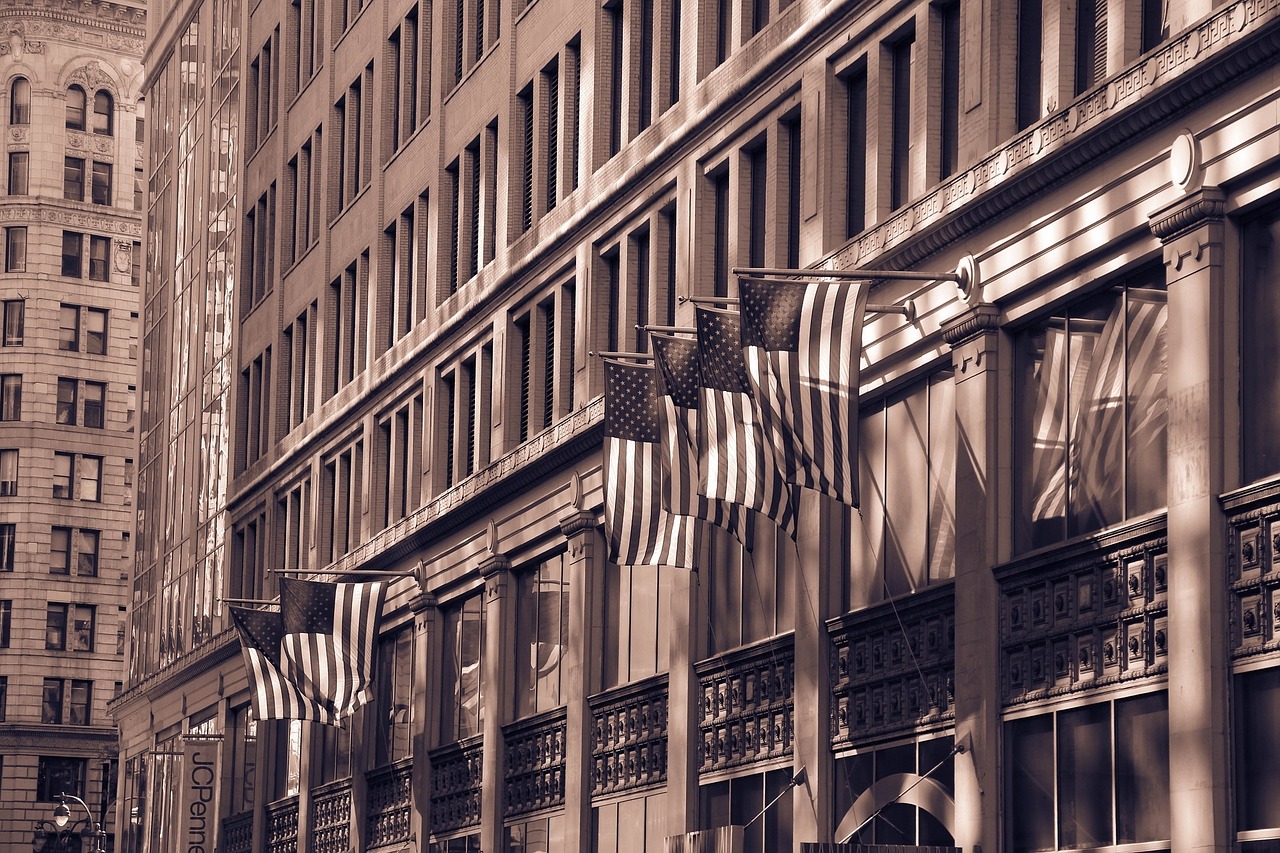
559;508;604;850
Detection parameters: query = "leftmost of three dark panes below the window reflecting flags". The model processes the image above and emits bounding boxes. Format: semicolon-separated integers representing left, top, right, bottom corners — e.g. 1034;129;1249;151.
1005;715;1057;850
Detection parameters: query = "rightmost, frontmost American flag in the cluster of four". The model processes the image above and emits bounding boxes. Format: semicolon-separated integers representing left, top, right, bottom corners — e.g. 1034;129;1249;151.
739;279;867;507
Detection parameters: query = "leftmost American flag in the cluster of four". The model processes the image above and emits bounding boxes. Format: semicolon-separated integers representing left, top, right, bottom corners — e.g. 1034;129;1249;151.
604;361;698;569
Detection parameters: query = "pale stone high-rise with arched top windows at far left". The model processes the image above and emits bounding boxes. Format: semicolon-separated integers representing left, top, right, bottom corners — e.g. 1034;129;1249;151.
0;1;145;849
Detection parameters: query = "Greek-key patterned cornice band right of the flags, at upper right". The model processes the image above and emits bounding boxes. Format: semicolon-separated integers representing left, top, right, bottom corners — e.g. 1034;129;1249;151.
817;0;1280;275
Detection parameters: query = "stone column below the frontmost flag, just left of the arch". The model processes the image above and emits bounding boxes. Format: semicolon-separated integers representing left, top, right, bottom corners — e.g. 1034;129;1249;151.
793;489;840;853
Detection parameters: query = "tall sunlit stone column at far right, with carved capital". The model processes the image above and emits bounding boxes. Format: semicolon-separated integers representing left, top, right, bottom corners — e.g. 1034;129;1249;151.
1151;187;1235;850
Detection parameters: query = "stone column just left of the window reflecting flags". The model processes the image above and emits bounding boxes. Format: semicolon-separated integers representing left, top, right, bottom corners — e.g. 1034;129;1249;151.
942;304;1011;853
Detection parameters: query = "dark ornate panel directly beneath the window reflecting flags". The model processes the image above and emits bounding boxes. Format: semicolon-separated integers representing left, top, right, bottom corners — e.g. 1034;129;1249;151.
996;525;1169;706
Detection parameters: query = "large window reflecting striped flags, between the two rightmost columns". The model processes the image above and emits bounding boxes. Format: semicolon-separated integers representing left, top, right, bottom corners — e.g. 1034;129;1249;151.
1014;268;1169;551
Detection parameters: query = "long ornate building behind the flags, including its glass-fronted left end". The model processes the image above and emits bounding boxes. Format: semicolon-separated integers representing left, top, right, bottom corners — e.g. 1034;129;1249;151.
113;0;1280;853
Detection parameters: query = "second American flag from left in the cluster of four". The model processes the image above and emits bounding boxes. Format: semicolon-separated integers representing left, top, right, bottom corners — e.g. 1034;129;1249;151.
650;334;746;544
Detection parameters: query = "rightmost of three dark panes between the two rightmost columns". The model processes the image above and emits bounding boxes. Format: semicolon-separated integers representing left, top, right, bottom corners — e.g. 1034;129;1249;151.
1115;692;1169;844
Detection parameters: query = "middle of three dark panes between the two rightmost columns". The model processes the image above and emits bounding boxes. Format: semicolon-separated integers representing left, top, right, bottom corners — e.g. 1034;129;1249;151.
1057;703;1111;848
